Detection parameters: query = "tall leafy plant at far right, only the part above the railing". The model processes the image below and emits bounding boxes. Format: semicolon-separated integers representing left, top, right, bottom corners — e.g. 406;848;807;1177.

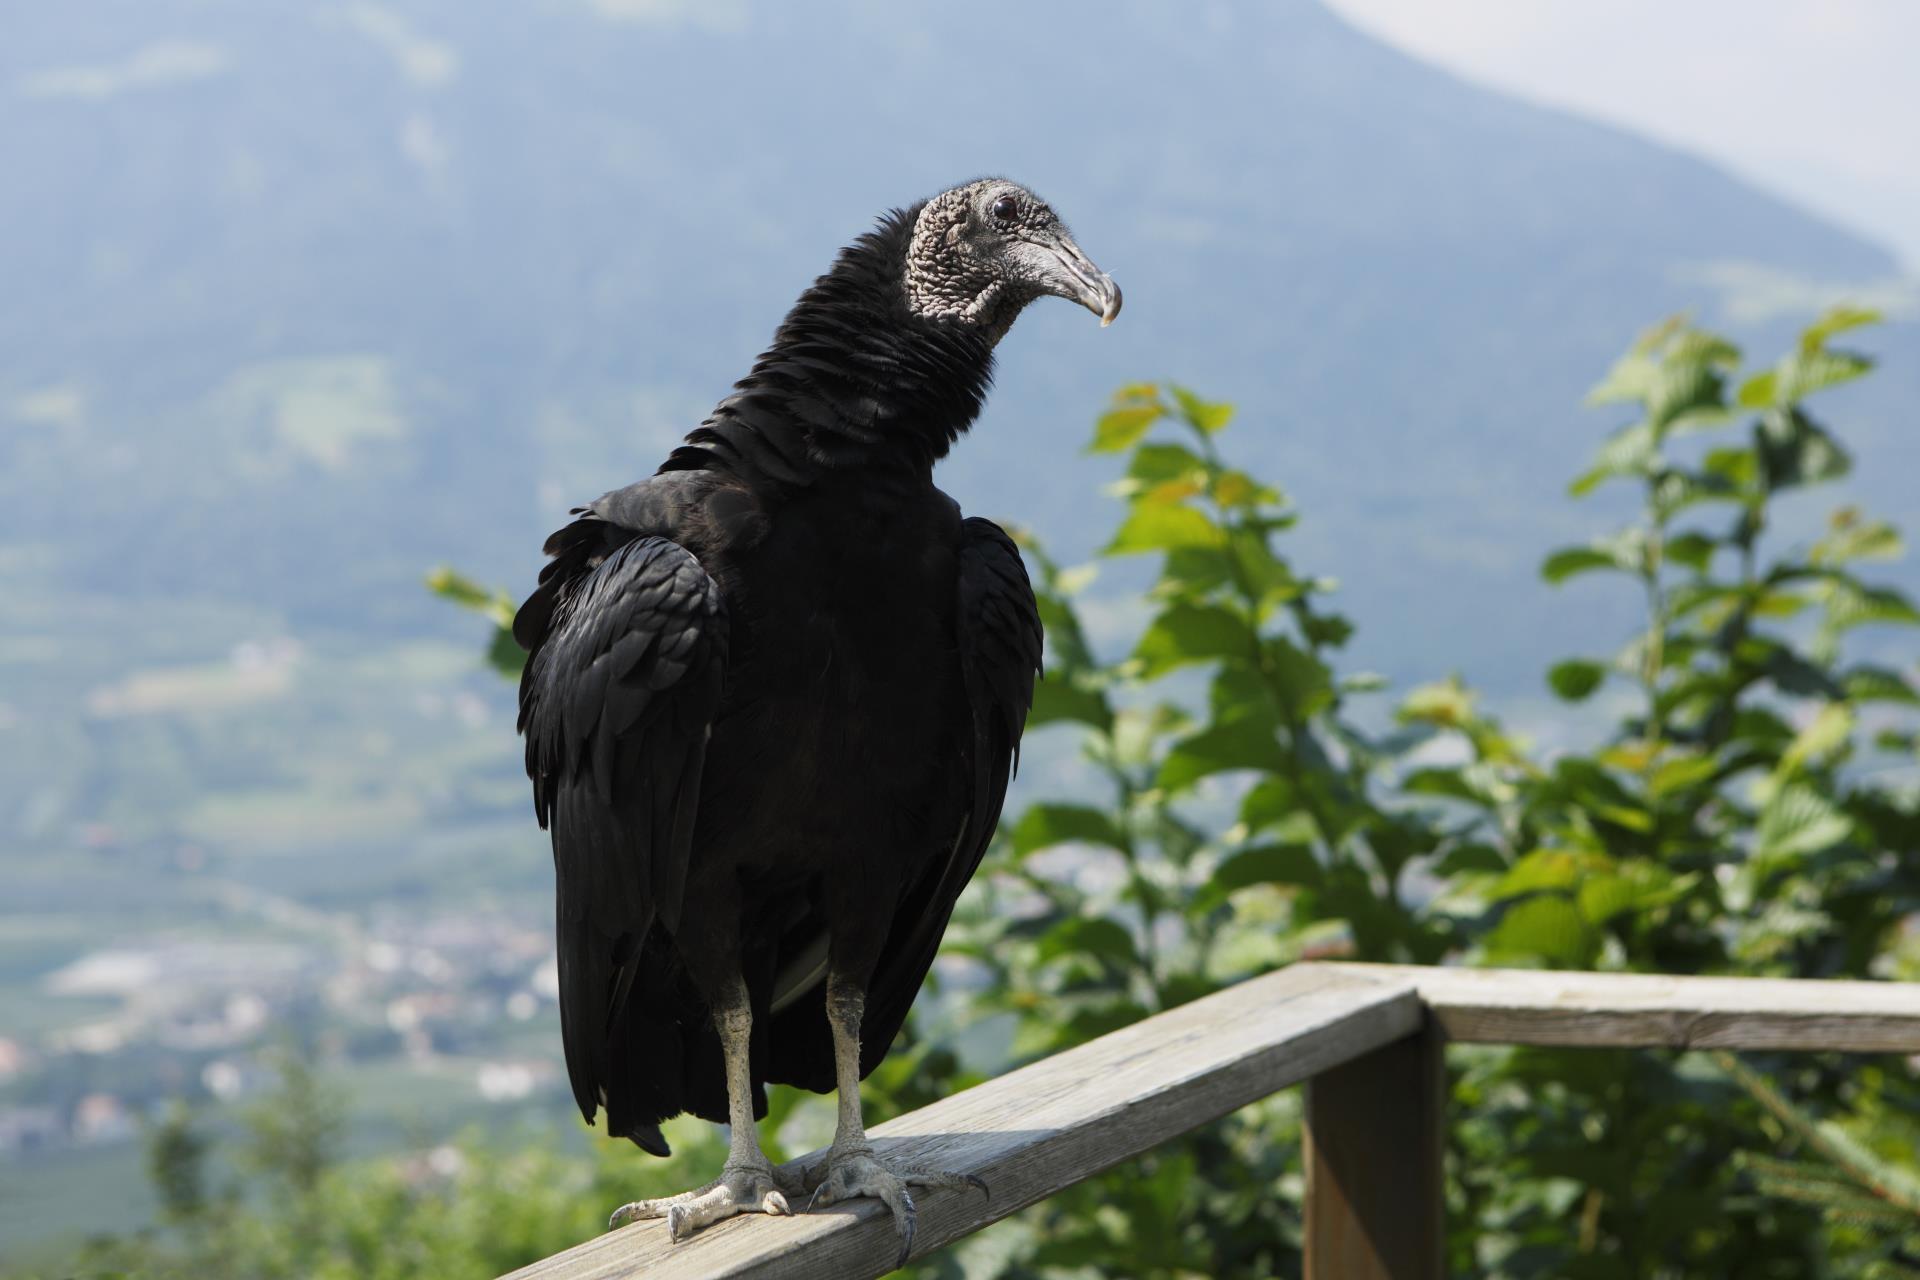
1407;313;1920;977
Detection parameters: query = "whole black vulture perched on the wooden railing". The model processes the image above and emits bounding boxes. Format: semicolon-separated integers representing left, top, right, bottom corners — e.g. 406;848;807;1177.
513;178;1119;1257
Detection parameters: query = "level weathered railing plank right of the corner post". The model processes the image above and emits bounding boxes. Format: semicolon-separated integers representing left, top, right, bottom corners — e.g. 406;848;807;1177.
1321;963;1920;1054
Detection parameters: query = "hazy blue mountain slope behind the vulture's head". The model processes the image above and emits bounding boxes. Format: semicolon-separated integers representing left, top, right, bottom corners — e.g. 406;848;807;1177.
0;0;1889;666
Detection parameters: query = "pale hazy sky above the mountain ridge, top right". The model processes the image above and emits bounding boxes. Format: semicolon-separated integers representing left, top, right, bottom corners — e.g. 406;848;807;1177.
1329;0;1920;274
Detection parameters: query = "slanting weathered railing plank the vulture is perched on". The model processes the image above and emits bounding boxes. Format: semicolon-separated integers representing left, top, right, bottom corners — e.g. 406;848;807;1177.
513;965;1423;1280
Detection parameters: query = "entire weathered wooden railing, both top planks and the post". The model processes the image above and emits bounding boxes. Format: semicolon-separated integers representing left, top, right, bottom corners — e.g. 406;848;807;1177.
513;963;1920;1280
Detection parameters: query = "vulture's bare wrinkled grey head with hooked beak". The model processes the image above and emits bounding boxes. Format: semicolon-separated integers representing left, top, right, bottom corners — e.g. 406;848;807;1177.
906;178;1119;342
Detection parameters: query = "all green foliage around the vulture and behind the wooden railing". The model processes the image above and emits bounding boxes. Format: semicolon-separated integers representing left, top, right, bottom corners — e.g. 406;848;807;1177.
41;309;1920;1280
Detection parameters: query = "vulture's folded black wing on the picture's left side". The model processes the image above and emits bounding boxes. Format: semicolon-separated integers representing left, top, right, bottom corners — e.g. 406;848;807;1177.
515;510;728;1132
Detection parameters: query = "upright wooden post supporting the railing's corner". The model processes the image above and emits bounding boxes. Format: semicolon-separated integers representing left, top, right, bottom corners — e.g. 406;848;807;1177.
1306;1017;1448;1280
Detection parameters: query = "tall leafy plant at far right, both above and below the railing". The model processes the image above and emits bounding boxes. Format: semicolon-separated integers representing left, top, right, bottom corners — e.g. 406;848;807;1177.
1404;313;1920;1276
